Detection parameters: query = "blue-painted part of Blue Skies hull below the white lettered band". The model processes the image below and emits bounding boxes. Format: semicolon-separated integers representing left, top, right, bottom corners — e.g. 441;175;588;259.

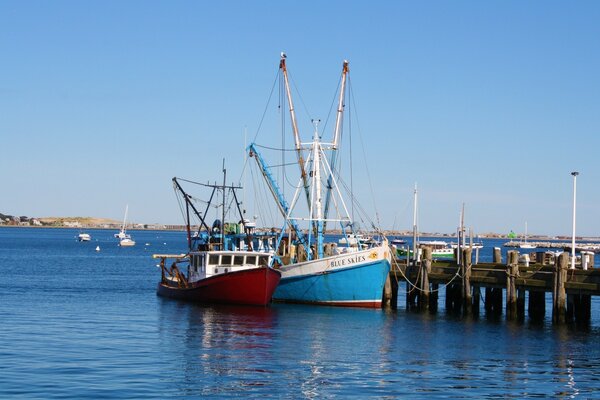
273;259;390;308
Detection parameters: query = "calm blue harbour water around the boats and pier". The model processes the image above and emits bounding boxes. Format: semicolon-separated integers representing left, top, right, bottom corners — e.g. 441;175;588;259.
0;228;600;399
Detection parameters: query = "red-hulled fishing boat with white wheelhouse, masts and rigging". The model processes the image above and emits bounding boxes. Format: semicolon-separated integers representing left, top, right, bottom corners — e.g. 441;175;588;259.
153;170;281;306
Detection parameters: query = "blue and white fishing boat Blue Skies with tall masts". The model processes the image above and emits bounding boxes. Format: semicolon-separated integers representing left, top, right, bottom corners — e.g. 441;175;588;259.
248;54;391;308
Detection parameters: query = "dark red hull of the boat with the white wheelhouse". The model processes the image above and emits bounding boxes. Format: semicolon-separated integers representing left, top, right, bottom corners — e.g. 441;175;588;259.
156;267;281;306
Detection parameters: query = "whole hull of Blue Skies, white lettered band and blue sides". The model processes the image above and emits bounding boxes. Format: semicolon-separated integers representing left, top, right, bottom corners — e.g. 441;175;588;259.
273;246;391;308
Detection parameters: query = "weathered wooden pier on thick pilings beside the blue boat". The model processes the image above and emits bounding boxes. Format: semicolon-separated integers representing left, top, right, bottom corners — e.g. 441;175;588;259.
384;248;600;324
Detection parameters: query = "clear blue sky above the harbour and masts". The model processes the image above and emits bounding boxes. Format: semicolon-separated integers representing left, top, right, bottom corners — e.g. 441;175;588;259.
0;1;600;236
